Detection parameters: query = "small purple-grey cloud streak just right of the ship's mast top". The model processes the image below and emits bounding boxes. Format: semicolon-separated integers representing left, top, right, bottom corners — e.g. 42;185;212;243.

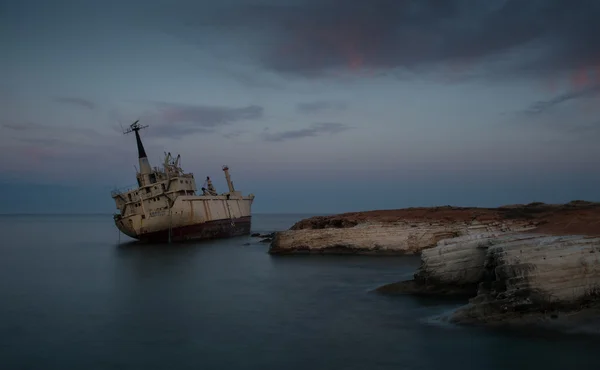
142;103;264;138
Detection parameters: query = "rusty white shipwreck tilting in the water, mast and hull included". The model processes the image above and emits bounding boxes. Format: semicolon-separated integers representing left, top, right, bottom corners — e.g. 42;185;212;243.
111;120;254;242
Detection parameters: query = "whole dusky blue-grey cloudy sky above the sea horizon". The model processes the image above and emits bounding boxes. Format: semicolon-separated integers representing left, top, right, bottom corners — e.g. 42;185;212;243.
0;0;600;213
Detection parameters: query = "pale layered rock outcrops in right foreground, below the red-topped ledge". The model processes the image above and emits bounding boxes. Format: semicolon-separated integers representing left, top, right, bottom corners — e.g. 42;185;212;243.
377;233;600;323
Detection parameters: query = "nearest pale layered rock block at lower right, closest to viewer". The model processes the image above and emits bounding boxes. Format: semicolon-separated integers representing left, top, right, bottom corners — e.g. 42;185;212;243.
452;235;600;322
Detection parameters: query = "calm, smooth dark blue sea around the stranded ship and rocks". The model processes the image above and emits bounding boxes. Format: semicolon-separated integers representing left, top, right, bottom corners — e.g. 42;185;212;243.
0;215;600;370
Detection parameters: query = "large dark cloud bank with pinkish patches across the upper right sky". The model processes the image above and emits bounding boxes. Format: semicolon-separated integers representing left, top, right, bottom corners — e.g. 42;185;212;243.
158;0;600;80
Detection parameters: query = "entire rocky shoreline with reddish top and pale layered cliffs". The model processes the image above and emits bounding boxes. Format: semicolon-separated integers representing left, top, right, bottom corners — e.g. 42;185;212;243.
269;201;600;324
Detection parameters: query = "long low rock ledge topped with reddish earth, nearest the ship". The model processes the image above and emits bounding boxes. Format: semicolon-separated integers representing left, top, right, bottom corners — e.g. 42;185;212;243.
269;202;600;254
